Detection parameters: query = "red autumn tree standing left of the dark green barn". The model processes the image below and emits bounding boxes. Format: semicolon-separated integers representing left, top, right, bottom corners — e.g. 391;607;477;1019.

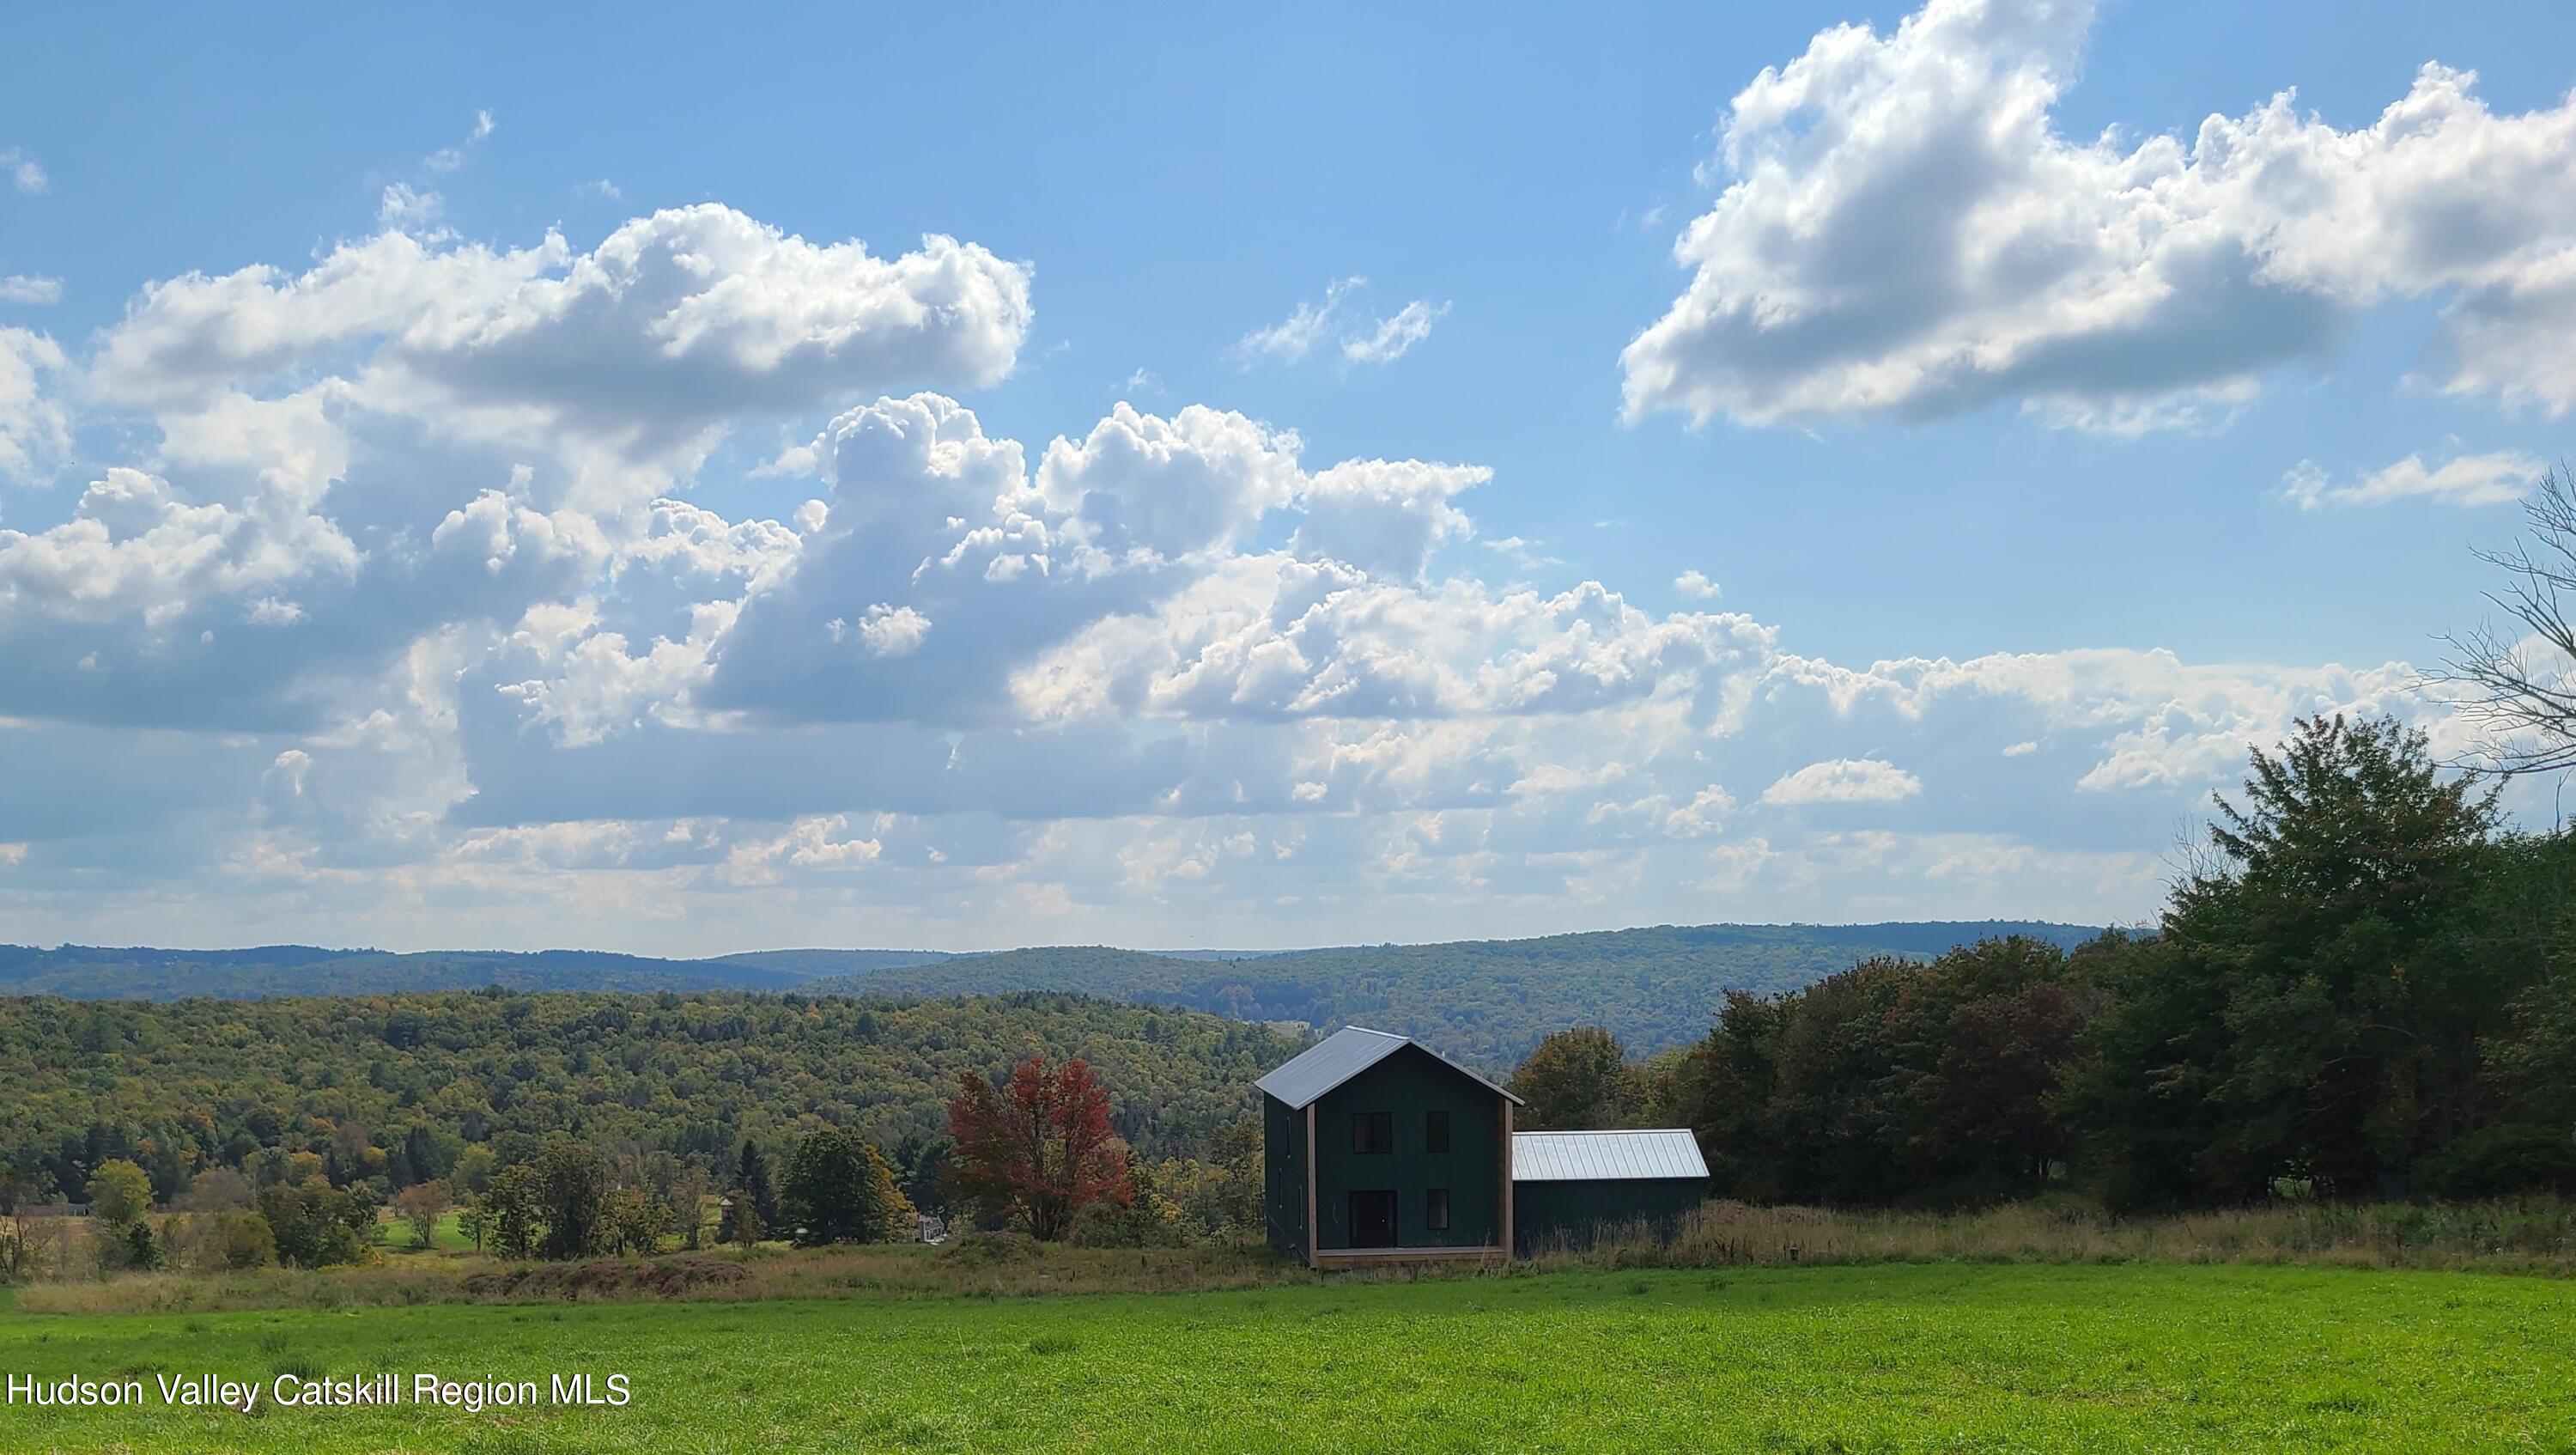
948;1056;1133;1241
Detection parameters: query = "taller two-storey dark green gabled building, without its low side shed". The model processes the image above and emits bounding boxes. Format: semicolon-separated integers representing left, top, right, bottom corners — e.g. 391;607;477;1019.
1260;1025;1520;1267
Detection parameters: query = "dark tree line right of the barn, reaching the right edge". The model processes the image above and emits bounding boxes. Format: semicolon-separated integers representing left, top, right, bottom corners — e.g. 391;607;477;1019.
1512;719;2576;1208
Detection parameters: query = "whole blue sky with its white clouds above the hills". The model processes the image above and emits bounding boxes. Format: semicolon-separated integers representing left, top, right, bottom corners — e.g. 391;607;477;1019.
0;3;2576;950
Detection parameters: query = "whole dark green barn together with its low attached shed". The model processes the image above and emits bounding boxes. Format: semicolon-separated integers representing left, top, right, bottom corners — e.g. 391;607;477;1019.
1260;1025;1708;1267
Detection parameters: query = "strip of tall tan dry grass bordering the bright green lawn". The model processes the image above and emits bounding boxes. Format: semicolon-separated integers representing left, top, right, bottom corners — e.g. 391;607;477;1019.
18;1197;2576;1313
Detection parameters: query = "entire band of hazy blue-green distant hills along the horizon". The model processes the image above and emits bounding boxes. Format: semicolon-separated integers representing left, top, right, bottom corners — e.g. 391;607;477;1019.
0;919;2099;1068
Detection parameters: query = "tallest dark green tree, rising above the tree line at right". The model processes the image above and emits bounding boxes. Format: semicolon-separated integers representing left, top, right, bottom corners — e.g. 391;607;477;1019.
2069;719;2514;1205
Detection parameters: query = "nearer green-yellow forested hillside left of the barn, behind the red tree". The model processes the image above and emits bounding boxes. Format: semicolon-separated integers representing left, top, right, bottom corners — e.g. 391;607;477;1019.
0;991;1298;1200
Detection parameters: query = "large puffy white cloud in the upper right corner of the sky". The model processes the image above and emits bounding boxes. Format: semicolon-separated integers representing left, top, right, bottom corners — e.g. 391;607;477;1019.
1620;0;2576;430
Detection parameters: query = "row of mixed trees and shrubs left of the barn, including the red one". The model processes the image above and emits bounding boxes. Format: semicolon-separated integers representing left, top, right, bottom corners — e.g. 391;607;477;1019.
0;1056;1262;1277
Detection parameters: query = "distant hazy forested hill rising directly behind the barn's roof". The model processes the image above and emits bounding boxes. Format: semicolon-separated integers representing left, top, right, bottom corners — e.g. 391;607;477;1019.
806;922;2097;1071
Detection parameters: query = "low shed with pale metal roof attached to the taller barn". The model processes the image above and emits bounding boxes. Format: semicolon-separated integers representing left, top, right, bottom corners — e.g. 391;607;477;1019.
1512;1128;1708;1254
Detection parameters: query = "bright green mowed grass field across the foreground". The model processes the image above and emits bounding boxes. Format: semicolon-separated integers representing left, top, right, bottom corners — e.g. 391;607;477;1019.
0;1264;2576;1452
